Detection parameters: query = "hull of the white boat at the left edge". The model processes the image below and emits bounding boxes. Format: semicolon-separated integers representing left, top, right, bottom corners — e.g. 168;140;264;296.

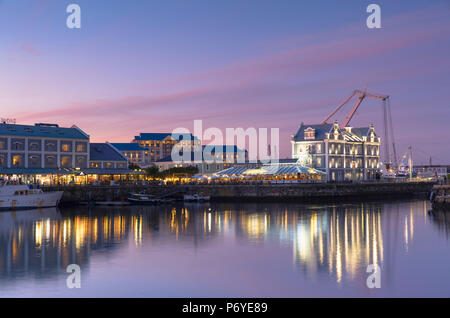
0;191;64;211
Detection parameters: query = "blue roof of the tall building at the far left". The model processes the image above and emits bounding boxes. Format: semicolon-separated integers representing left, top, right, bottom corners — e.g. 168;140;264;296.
0;124;89;140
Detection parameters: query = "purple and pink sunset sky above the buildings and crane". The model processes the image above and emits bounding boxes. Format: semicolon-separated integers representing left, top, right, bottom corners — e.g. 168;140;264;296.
0;0;450;164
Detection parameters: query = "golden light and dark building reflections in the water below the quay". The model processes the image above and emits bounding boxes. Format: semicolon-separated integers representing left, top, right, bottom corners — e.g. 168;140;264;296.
0;201;444;292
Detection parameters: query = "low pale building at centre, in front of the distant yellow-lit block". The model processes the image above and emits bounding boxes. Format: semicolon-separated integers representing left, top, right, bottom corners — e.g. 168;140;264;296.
155;145;248;175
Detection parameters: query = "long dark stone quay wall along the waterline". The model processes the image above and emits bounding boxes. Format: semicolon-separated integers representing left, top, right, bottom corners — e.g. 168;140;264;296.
43;182;434;204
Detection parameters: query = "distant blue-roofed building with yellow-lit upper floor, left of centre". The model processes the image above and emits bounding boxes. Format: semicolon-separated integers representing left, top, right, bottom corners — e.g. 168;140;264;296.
132;133;201;163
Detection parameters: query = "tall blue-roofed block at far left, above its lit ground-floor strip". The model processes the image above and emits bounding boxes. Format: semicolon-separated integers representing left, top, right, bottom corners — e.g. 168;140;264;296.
0;123;89;171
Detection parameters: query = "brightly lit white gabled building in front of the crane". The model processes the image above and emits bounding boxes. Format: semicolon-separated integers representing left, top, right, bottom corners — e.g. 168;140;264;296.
291;122;381;181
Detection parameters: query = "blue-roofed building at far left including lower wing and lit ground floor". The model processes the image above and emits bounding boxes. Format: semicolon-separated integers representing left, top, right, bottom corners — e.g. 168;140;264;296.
0;123;142;185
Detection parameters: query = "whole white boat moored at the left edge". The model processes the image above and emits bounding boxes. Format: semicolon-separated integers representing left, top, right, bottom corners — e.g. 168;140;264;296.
0;180;63;210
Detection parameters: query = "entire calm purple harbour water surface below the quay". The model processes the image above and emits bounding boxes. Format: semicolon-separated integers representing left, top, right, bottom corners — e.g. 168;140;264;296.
0;201;450;297
